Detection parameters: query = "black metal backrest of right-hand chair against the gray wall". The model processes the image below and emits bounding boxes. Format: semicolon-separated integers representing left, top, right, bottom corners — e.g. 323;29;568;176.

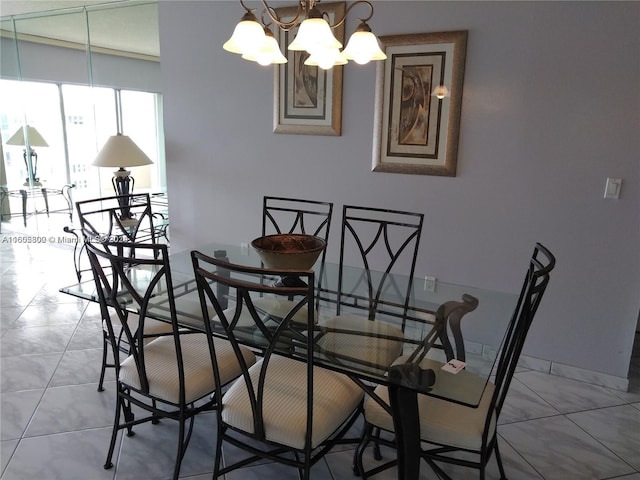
336;205;424;325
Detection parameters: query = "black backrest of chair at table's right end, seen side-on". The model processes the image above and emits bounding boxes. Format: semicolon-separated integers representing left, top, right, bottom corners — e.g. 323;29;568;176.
490;243;556;415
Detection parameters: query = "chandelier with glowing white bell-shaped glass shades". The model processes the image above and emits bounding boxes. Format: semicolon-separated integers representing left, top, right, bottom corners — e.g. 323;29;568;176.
222;0;387;70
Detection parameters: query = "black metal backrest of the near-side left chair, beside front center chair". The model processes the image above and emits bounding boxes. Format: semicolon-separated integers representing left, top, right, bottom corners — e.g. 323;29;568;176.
86;241;184;400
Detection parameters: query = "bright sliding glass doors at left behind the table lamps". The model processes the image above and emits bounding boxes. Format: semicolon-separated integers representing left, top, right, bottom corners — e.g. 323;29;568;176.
0;80;164;200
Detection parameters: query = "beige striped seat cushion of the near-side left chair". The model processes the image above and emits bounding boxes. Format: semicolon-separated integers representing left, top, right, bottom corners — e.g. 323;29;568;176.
119;333;255;404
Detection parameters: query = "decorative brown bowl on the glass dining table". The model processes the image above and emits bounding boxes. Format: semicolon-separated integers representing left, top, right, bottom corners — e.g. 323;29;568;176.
251;233;327;270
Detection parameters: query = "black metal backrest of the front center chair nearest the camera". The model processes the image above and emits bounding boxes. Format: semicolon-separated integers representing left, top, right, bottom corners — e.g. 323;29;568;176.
191;251;314;440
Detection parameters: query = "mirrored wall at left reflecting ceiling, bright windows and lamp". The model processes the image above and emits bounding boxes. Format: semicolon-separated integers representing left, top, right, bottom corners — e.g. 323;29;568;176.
0;1;166;232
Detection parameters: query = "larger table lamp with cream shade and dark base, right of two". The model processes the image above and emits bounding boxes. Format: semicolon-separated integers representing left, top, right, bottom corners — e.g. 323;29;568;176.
93;133;153;221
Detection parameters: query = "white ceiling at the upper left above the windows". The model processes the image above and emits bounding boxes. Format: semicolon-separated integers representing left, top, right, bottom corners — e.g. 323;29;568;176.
0;0;160;57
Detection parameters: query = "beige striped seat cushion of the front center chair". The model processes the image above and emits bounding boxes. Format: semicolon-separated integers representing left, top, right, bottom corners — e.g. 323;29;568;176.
222;355;364;449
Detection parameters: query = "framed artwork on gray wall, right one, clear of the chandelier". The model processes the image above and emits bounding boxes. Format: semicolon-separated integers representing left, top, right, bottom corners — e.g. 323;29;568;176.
372;30;468;177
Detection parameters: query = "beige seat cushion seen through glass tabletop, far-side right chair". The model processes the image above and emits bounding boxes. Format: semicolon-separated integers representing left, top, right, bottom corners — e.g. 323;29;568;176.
317;315;403;372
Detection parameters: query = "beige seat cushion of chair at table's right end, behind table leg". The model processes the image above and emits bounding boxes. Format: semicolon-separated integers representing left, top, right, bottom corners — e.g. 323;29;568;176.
364;374;496;450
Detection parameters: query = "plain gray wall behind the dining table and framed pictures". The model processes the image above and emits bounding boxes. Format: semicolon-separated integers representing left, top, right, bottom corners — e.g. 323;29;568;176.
159;1;640;378
